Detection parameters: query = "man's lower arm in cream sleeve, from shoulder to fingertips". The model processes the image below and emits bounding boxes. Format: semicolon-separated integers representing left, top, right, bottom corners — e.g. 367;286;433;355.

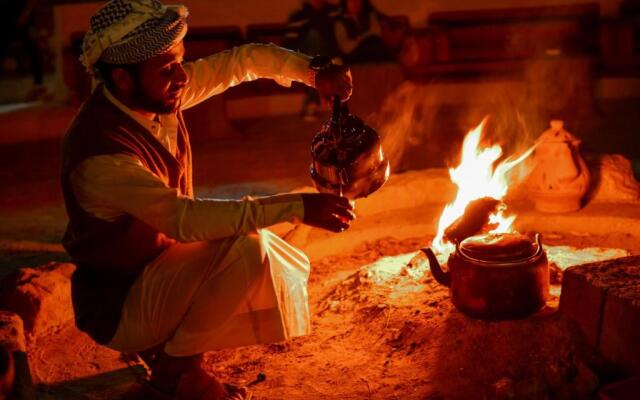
71;155;354;242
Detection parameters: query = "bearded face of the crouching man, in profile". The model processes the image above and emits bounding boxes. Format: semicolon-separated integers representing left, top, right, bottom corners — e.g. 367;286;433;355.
132;41;188;114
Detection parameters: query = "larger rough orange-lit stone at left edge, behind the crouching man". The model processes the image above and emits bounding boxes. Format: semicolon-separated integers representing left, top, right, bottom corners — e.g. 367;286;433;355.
0;262;75;337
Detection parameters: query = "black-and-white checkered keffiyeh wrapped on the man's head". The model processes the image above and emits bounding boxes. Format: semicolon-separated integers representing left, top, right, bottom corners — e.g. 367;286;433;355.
80;0;189;74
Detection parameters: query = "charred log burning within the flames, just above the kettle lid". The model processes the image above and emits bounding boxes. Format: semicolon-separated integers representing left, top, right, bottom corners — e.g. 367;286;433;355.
444;197;501;243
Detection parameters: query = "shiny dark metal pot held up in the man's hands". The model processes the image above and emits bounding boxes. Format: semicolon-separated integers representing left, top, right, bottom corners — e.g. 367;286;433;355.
310;97;389;199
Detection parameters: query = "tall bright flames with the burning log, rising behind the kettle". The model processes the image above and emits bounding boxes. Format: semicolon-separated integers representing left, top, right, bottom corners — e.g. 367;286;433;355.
432;117;534;256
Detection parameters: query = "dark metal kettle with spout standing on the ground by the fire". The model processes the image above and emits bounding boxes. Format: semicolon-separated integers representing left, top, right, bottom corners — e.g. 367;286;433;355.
421;233;549;320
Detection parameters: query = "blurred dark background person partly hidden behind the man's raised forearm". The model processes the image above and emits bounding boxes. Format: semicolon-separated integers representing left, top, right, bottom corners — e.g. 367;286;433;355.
284;0;338;121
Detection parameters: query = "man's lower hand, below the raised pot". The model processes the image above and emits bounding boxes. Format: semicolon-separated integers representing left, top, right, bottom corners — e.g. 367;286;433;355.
302;193;356;232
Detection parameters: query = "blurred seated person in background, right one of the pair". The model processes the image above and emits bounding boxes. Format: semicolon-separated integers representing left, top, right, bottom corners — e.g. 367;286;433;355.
334;0;393;64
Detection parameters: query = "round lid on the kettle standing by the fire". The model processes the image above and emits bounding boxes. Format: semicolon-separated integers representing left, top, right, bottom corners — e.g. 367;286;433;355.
459;233;537;262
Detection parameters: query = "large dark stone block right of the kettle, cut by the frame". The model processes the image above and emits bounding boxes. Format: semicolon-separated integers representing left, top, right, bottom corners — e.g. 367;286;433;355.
560;256;640;373
